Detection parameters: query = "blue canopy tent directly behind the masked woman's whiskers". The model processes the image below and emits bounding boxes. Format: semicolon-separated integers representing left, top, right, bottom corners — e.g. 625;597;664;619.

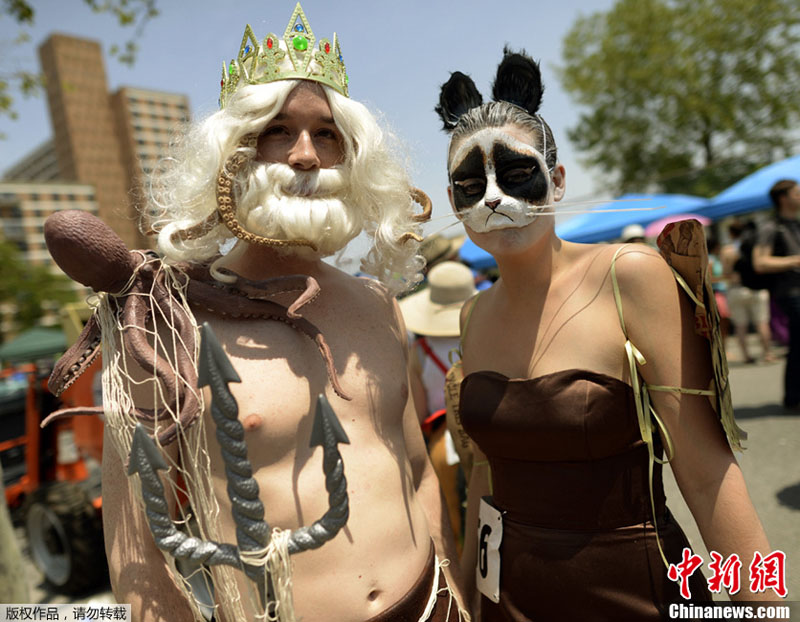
459;194;708;270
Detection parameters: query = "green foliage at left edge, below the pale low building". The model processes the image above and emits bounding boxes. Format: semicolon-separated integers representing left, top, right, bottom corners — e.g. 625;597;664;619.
0;240;78;338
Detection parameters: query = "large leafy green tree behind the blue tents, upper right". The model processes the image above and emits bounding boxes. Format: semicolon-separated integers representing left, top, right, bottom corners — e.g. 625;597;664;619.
558;0;800;196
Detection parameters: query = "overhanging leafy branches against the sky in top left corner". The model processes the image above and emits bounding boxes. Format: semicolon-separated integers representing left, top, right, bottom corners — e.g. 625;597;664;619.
0;0;158;128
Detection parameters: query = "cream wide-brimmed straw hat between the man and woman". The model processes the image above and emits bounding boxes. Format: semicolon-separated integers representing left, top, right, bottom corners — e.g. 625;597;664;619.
399;261;477;337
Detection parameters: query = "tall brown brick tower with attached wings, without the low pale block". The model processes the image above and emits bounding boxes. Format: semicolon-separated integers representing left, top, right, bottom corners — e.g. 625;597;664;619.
3;34;189;248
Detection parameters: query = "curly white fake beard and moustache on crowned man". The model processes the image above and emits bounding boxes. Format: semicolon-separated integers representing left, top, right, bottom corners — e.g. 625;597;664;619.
238;163;363;256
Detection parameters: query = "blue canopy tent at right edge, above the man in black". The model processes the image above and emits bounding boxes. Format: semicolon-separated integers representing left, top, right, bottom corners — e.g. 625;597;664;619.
697;155;800;220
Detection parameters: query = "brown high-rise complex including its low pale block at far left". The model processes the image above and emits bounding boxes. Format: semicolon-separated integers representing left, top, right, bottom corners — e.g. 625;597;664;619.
0;34;189;342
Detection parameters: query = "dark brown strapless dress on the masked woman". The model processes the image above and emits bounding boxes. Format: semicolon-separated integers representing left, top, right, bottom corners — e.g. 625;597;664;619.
460;369;711;622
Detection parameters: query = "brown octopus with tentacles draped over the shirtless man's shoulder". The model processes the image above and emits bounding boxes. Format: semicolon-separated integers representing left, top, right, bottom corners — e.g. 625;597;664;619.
42;210;350;445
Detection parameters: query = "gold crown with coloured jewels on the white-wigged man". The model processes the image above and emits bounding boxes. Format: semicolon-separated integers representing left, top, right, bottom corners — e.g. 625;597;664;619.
219;2;349;108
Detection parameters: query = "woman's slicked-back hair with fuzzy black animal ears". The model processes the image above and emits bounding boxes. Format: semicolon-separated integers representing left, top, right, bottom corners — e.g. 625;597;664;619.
435;47;558;173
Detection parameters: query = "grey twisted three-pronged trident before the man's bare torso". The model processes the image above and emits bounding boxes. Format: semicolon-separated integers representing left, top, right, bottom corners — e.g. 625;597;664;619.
128;324;350;599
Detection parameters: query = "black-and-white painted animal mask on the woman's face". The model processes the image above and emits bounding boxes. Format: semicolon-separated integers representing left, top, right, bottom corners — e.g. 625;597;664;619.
450;128;553;233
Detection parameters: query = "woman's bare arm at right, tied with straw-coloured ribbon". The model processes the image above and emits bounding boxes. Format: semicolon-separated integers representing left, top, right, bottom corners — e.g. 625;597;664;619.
617;250;771;600
